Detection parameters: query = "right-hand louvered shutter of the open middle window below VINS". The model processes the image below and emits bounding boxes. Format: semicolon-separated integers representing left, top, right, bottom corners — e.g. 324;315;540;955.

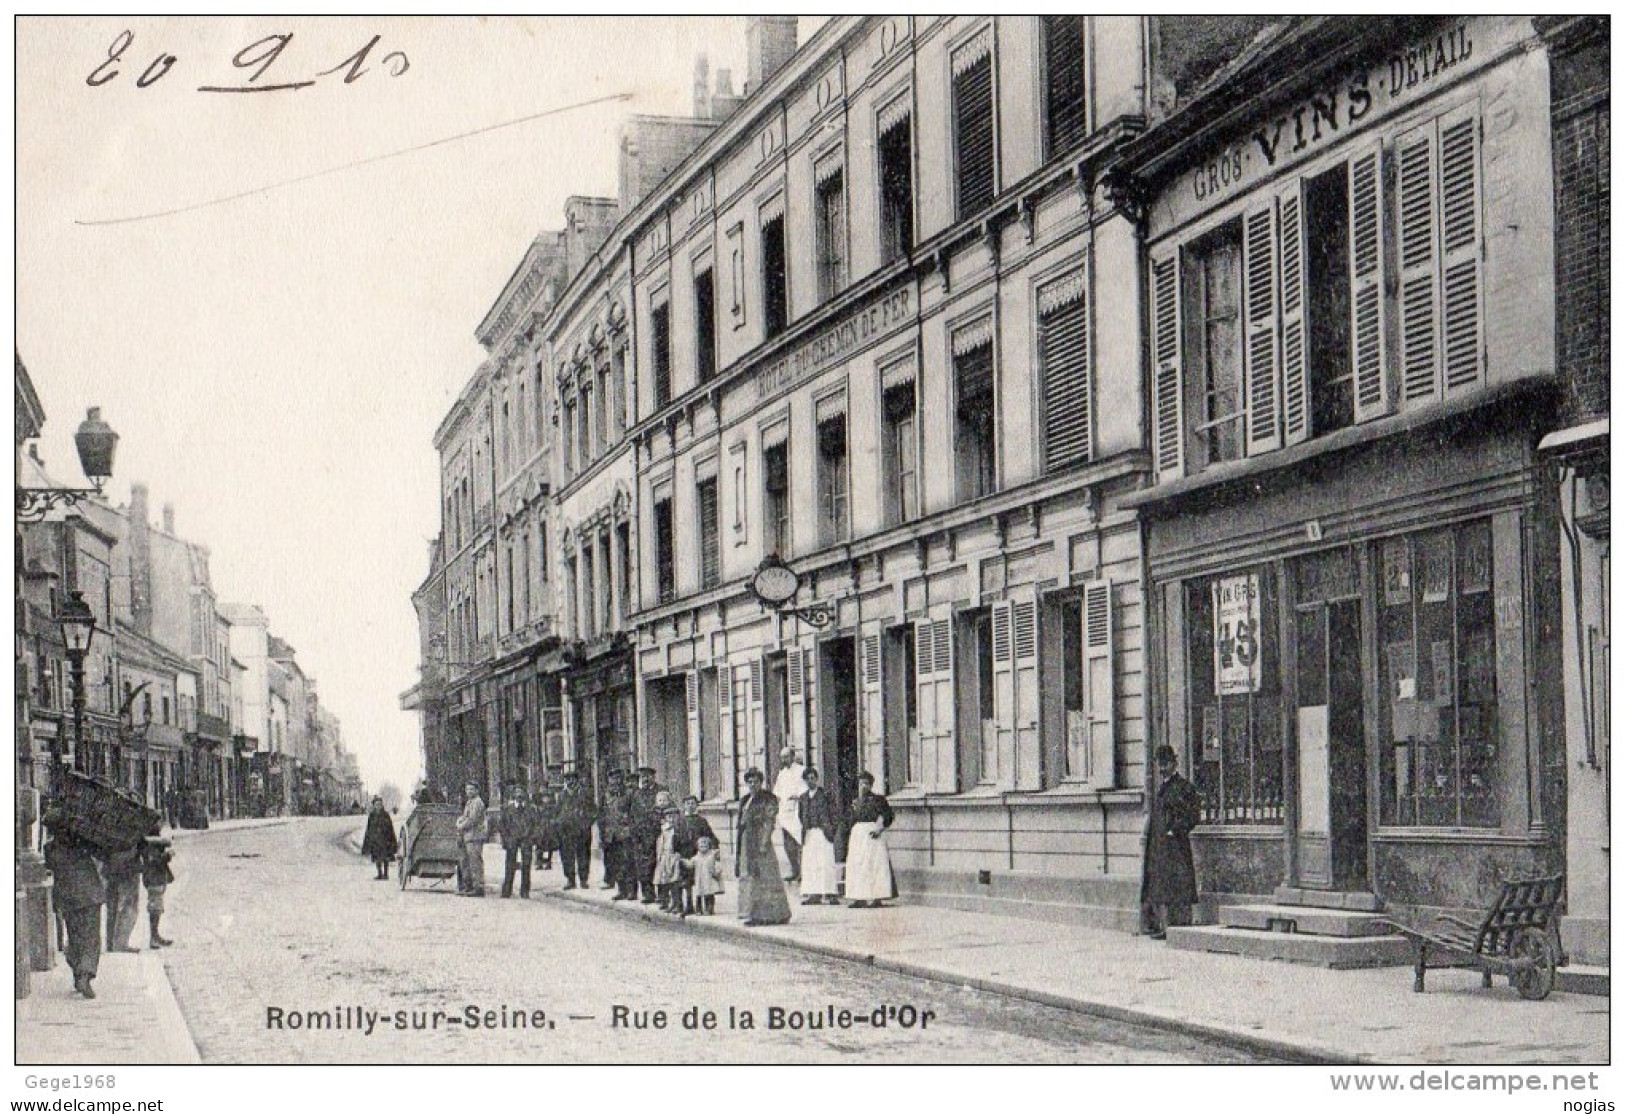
1349;143;1388;422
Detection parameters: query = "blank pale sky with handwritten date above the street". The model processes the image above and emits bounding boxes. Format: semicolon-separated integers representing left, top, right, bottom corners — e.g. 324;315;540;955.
15;16;767;802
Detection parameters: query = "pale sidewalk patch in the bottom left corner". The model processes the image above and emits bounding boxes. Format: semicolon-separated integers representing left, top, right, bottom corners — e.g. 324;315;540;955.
16;952;200;1064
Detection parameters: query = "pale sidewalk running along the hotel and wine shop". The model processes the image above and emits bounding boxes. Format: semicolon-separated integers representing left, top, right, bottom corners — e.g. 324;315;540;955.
536;862;1609;1065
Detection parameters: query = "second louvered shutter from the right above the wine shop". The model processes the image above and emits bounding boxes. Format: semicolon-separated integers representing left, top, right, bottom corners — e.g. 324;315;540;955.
1394;123;1438;403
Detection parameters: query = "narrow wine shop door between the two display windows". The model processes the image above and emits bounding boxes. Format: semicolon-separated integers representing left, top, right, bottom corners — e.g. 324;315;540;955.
1297;599;1370;890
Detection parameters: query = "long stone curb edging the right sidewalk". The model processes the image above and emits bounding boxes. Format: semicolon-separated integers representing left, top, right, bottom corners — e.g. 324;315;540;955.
541;890;1345;1067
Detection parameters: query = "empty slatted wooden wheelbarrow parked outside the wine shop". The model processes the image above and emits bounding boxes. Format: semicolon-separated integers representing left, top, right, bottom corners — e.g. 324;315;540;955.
1388;874;1563;1002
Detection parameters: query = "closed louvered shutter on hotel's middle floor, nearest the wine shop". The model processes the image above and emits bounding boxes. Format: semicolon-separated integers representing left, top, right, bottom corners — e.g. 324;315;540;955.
1038;271;1095;473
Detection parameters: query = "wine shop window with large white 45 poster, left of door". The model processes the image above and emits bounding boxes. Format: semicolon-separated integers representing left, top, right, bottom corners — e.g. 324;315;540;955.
1185;570;1282;825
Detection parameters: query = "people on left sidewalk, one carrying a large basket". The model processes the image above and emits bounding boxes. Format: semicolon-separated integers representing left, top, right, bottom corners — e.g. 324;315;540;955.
44;807;176;999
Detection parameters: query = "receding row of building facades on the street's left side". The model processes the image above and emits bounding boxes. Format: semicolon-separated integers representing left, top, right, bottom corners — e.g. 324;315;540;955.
16;357;362;823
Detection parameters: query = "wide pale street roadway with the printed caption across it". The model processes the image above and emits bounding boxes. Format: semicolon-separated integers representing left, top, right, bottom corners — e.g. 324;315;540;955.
155;818;1267;1064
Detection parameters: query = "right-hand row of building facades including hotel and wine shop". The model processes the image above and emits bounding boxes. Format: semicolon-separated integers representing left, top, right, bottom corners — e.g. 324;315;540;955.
405;16;1609;956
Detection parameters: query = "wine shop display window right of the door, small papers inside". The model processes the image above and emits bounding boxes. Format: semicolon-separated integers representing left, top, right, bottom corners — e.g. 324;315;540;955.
1378;521;1502;828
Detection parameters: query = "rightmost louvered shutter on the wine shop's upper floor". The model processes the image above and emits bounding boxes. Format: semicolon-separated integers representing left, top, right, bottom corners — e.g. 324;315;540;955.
1438;104;1484;395
